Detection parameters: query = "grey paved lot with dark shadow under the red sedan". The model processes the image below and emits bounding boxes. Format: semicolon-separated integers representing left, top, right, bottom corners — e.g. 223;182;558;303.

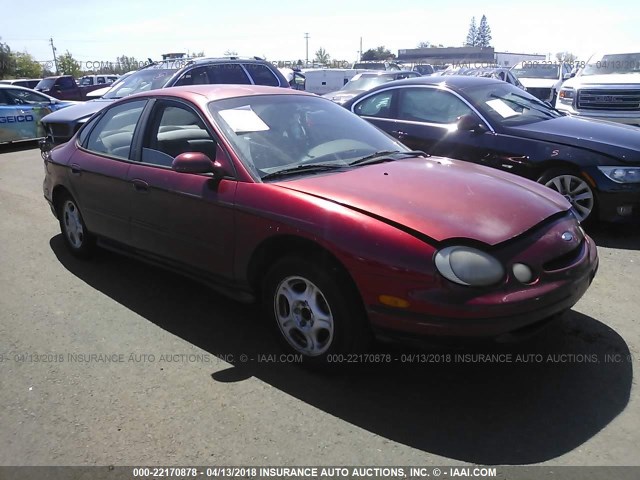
0;147;640;465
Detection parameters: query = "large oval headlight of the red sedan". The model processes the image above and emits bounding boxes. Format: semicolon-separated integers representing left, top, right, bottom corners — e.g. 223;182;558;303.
435;247;504;287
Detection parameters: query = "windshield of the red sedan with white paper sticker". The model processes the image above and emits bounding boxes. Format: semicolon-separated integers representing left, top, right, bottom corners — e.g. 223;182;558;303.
209;95;408;178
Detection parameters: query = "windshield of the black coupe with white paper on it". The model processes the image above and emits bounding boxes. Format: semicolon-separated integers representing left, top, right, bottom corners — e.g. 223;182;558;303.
465;83;562;127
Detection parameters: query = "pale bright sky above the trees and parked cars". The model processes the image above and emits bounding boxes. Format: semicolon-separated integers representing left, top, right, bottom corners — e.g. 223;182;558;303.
0;0;640;62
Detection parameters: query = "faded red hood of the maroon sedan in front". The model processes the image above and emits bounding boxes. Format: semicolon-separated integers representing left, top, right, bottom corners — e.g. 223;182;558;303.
276;157;570;245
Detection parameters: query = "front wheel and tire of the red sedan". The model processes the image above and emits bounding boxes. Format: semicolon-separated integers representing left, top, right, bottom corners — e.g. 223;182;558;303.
262;255;372;368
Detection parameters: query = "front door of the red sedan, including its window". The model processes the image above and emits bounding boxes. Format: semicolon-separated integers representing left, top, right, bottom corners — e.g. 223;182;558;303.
128;100;237;278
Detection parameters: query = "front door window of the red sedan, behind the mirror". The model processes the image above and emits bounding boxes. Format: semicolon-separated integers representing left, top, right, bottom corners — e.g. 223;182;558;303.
142;101;216;167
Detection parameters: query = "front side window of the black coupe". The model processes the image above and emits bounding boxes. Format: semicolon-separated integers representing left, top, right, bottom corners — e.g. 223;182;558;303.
398;88;472;124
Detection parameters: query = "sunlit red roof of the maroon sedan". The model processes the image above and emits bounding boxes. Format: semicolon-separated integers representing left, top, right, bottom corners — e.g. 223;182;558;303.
125;84;312;106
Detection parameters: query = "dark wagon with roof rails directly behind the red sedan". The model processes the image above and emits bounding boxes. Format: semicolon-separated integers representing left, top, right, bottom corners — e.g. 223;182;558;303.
41;57;289;147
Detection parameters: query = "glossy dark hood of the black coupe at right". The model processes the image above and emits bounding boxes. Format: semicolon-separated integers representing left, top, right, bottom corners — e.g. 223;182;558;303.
507;116;640;163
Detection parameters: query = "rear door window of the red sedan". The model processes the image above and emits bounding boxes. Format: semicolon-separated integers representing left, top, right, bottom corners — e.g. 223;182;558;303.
87;100;147;159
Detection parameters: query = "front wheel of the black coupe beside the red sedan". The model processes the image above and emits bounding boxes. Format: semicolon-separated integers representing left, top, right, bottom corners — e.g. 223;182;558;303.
538;168;598;224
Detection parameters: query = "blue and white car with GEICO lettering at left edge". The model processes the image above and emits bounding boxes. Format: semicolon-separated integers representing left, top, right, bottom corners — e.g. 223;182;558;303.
0;83;75;143
